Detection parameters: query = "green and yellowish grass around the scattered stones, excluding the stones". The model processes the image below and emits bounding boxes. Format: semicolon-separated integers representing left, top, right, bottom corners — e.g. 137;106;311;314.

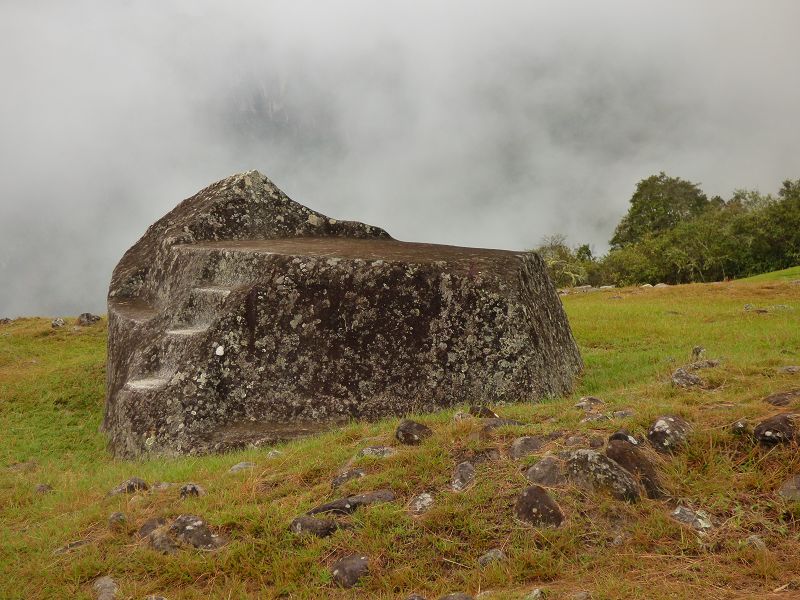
0;278;800;600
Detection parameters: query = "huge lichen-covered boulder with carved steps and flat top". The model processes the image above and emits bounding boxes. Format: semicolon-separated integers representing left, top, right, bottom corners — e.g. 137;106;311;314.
103;171;582;457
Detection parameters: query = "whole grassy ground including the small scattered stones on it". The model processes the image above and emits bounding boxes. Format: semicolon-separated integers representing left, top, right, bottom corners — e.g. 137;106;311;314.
0;274;800;600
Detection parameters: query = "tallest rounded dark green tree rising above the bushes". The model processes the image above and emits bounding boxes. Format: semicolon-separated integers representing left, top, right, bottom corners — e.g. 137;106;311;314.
611;171;718;248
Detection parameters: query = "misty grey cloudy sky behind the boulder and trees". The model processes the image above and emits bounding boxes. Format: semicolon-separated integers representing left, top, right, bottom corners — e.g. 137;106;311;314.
0;0;800;317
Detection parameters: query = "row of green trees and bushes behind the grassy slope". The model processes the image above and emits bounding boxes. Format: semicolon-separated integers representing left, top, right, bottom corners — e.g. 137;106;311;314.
535;172;800;287
